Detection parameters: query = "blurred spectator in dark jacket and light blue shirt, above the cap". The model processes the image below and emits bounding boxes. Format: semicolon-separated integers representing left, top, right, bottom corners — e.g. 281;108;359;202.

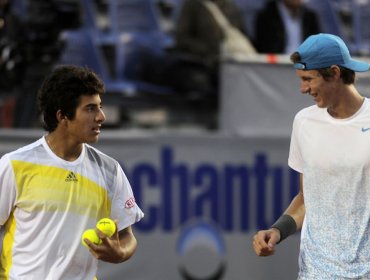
254;0;321;54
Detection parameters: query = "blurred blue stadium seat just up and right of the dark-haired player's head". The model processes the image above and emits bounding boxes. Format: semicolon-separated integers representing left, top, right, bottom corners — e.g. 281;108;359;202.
98;0;173;94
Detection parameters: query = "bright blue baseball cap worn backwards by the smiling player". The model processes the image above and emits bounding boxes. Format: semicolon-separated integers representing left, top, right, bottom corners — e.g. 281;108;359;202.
294;33;370;72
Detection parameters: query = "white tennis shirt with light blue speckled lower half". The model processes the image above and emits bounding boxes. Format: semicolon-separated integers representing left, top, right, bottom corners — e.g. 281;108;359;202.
289;99;370;280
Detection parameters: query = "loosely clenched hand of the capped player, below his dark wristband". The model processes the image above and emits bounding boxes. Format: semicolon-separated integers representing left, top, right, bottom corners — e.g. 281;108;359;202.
253;228;280;257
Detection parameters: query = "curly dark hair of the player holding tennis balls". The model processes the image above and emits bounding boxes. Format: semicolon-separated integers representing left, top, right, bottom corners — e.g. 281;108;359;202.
38;65;105;132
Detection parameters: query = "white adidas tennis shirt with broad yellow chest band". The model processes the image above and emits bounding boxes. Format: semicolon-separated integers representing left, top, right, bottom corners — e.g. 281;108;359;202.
0;137;144;280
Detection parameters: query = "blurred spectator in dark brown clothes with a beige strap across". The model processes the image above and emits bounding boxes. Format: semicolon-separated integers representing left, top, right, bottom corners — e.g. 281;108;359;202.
166;0;251;129
